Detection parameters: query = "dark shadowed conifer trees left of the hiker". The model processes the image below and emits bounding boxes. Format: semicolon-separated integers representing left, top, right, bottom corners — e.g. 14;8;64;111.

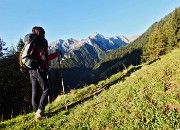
0;39;32;120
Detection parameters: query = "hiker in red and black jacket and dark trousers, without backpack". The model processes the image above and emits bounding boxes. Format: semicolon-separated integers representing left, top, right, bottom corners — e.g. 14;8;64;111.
19;27;62;121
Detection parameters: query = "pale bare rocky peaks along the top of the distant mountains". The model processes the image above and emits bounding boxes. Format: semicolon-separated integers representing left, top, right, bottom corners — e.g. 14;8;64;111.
49;32;138;54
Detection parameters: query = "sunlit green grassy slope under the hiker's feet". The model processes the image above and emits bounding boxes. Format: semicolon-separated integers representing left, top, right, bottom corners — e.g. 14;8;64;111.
0;50;180;130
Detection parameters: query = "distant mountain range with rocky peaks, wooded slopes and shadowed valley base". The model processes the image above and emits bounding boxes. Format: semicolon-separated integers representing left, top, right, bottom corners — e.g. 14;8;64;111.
49;32;138;87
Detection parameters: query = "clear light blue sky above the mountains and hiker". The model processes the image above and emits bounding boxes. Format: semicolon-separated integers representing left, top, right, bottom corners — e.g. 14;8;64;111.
0;0;180;46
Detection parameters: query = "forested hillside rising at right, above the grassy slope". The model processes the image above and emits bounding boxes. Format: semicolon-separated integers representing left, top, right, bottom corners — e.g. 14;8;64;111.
95;7;180;80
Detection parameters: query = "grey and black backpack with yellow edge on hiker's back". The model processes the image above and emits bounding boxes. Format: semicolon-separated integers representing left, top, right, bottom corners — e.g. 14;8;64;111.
20;34;40;70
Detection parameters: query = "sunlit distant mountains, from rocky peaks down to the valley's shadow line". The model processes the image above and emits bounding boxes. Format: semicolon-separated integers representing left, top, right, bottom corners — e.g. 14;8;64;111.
49;32;129;68
